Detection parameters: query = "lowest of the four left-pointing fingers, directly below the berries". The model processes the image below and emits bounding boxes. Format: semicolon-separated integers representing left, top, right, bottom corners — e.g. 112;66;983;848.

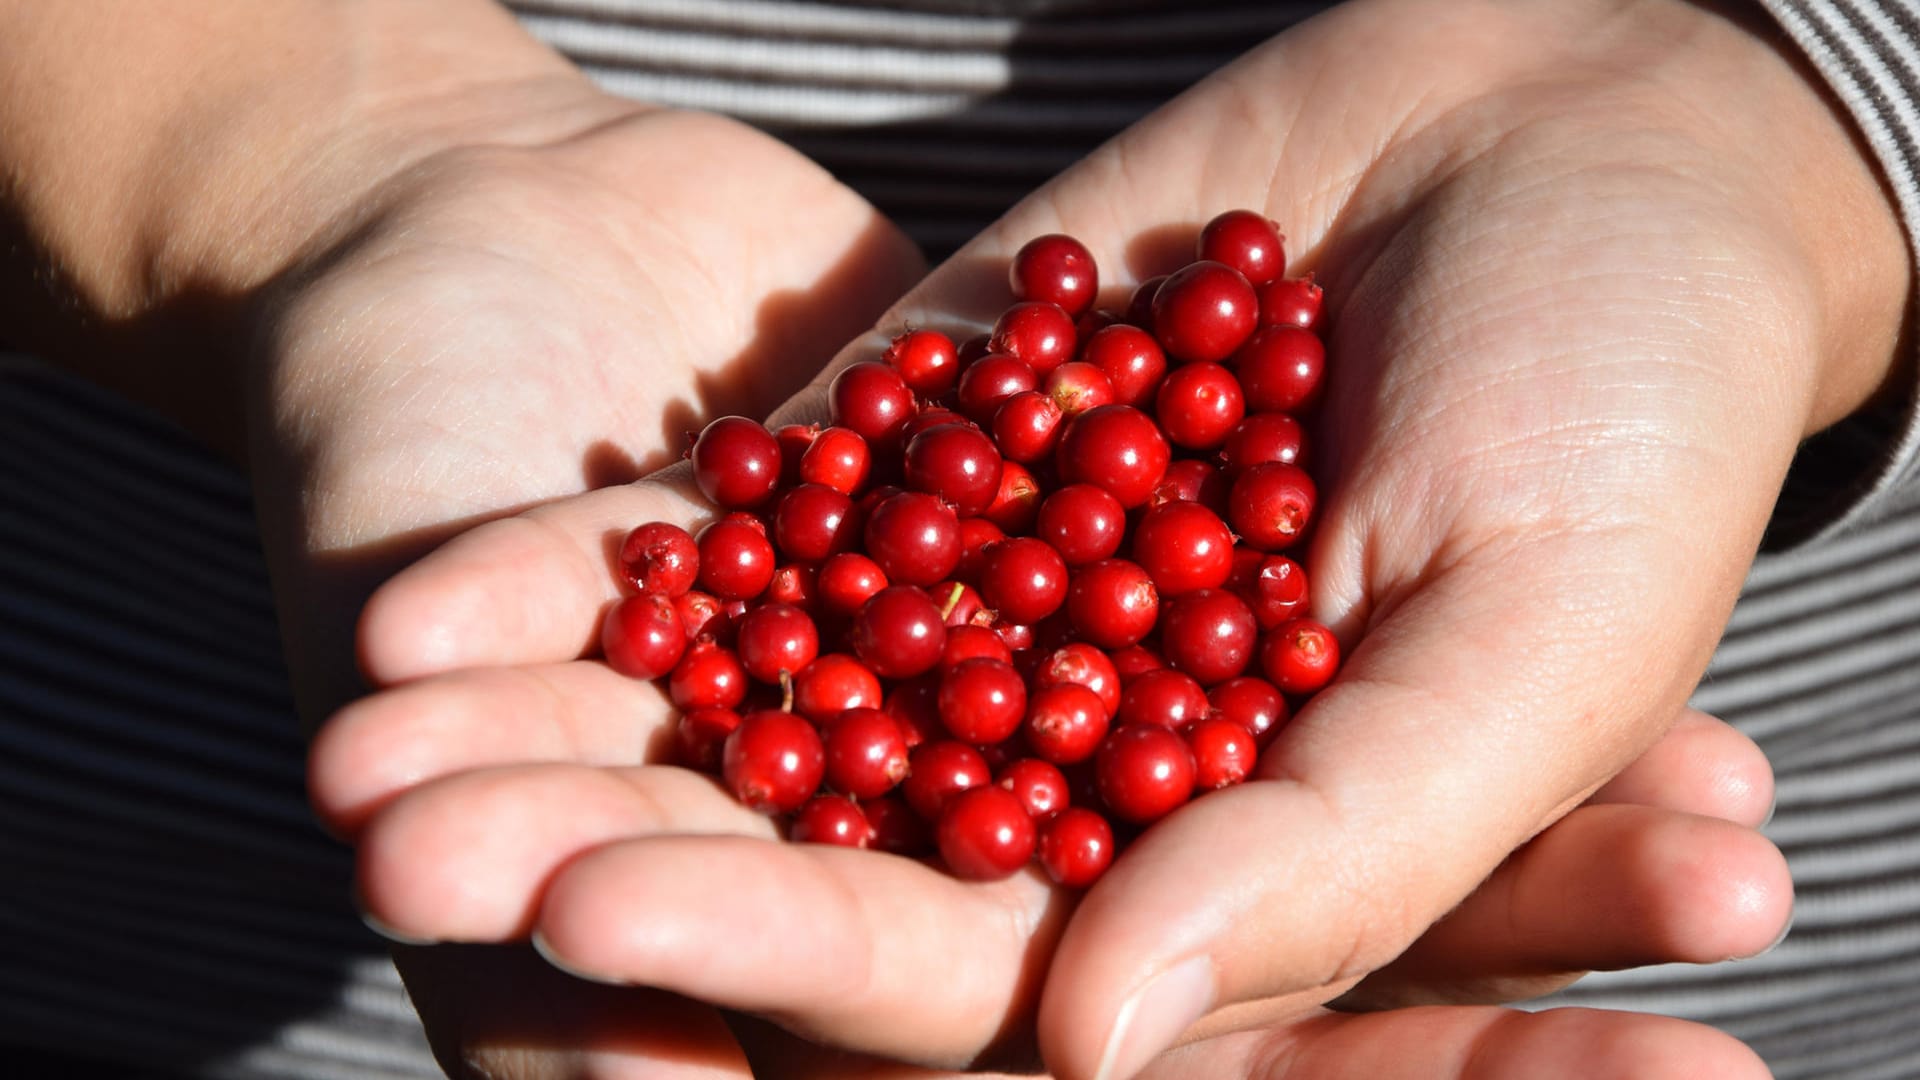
536;836;1068;1068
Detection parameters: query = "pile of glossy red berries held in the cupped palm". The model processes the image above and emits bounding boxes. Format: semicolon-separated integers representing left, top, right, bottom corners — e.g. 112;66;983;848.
601;211;1338;886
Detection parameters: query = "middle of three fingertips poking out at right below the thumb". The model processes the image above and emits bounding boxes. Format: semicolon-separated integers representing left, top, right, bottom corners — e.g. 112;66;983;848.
1340;803;1793;1009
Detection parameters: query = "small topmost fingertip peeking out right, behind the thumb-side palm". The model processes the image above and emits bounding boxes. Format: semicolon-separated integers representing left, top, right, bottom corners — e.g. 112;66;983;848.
1588;709;1774;826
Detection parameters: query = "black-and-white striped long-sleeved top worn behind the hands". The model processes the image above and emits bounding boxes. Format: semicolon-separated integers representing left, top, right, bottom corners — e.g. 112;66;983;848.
0;0;1920;1080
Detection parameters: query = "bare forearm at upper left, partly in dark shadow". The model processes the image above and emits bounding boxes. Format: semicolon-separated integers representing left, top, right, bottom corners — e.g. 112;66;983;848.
0;0;593;448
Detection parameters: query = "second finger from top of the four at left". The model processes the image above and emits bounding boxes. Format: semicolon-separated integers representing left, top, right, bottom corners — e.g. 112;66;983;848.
307;661;674;836
